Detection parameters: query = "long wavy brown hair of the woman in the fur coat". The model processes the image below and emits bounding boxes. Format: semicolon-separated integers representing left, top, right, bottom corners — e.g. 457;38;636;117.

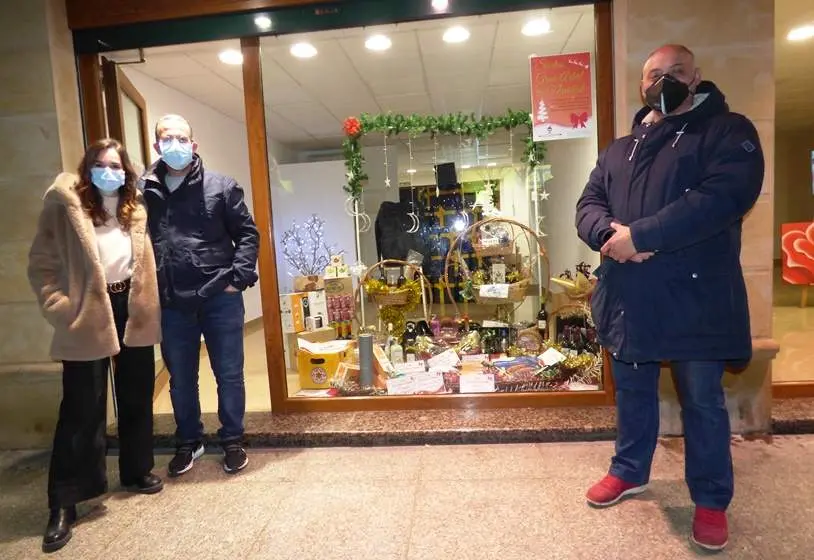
76;138;138;230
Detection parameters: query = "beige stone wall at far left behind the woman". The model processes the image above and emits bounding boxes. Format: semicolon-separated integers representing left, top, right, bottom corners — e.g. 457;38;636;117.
0;0;83;449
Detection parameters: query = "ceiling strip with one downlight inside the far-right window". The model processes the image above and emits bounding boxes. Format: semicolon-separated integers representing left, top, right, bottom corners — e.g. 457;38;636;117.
774;0;814;129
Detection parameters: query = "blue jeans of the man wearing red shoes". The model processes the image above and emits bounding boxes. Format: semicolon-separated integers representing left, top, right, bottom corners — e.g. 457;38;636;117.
610;360;735;510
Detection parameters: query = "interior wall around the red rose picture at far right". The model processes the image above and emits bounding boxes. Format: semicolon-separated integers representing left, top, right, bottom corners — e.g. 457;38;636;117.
774;128;814;259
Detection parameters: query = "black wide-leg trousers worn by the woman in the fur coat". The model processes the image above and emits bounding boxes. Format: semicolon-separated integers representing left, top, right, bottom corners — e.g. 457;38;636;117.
48;290;155;508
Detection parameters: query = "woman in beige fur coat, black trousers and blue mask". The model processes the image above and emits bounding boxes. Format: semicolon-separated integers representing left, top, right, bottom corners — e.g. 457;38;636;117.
28;139;163;552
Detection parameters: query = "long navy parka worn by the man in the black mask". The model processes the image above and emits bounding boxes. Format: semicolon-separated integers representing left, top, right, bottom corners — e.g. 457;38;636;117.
576;82;764;362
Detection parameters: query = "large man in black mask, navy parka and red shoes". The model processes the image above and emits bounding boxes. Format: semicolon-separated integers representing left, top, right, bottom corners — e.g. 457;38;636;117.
576;45;764;550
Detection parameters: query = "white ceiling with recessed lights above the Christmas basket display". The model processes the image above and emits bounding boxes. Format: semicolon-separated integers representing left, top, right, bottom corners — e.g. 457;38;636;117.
111;5;594;151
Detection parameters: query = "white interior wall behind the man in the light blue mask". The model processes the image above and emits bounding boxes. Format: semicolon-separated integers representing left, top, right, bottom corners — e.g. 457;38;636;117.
121;66;263;322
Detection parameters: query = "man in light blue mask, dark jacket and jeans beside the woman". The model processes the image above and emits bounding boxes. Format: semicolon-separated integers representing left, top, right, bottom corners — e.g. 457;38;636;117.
141;115;259;476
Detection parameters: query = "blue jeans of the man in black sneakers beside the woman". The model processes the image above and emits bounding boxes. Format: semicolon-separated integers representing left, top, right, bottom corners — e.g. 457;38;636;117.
161;292;246;444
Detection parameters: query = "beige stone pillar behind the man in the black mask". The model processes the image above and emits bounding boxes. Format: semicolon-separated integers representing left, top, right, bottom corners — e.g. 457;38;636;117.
613;0;777;434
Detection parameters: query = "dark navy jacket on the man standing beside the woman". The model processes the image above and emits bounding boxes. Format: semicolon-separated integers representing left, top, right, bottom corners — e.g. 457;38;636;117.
140;154;260;309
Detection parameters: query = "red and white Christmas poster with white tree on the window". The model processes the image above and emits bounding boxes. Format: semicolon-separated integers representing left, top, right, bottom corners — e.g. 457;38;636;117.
529;52;595;142
